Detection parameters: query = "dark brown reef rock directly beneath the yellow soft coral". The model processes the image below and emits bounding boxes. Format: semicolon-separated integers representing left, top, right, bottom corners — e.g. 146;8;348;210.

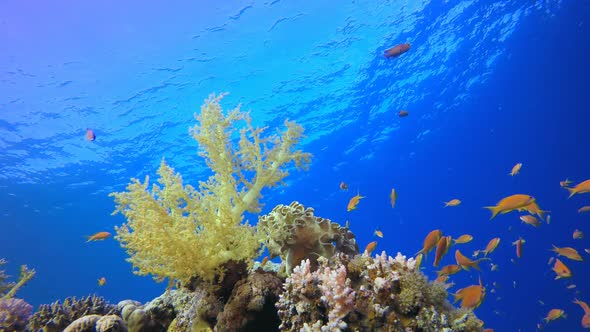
118;271;283;332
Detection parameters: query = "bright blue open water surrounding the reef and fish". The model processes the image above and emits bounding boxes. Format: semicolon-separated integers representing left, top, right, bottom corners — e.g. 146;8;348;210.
0;0;590;331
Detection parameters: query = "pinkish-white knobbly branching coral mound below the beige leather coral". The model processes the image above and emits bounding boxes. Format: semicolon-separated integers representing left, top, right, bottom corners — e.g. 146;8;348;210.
277;252;483;332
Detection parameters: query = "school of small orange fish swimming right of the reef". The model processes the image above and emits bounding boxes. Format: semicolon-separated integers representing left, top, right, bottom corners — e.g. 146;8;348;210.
340;167;590;332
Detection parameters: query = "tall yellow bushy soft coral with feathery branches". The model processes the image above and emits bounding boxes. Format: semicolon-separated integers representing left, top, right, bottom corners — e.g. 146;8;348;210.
111;95;311;282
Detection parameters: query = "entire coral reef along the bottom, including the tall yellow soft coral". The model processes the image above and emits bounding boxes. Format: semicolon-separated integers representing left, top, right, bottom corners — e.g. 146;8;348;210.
16;95;482;332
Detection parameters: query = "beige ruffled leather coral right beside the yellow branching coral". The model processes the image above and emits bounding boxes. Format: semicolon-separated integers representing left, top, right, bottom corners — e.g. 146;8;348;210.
257;202;358;274
